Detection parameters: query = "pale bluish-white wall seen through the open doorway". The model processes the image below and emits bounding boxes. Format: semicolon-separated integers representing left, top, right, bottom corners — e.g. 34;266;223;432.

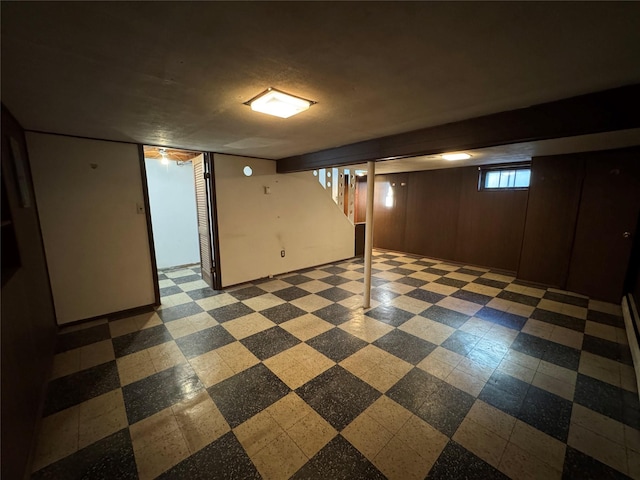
145;158;200;268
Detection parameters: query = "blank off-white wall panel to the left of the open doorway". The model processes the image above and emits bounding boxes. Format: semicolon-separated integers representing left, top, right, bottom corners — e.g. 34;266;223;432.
27;133;155;324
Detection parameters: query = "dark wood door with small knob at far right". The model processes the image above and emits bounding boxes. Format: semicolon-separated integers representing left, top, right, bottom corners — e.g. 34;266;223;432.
567;149;640;303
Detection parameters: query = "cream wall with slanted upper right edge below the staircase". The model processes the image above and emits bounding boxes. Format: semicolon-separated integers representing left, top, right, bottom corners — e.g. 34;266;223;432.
214;154;354;286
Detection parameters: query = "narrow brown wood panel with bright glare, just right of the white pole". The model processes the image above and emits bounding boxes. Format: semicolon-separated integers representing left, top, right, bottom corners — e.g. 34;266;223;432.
373;174;408;252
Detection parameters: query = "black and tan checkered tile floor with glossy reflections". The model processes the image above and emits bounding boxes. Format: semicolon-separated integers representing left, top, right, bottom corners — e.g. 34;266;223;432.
33;251;640;480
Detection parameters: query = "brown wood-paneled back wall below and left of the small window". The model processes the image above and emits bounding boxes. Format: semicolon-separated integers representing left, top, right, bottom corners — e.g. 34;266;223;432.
374;167;527;271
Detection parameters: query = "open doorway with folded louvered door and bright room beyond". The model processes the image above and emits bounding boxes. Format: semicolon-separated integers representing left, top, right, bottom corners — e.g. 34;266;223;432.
143;146;220;303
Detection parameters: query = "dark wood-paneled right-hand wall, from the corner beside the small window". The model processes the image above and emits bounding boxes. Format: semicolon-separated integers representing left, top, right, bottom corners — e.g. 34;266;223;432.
518;147;640;303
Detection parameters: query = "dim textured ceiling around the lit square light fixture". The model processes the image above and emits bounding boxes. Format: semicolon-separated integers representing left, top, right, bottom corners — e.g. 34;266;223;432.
1;2;640;159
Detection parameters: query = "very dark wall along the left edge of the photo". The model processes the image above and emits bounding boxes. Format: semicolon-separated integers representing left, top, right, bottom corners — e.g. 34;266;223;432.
1;107;57;479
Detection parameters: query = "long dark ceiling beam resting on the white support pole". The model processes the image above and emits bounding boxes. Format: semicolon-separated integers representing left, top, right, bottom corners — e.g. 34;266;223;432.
277;84;640;173
